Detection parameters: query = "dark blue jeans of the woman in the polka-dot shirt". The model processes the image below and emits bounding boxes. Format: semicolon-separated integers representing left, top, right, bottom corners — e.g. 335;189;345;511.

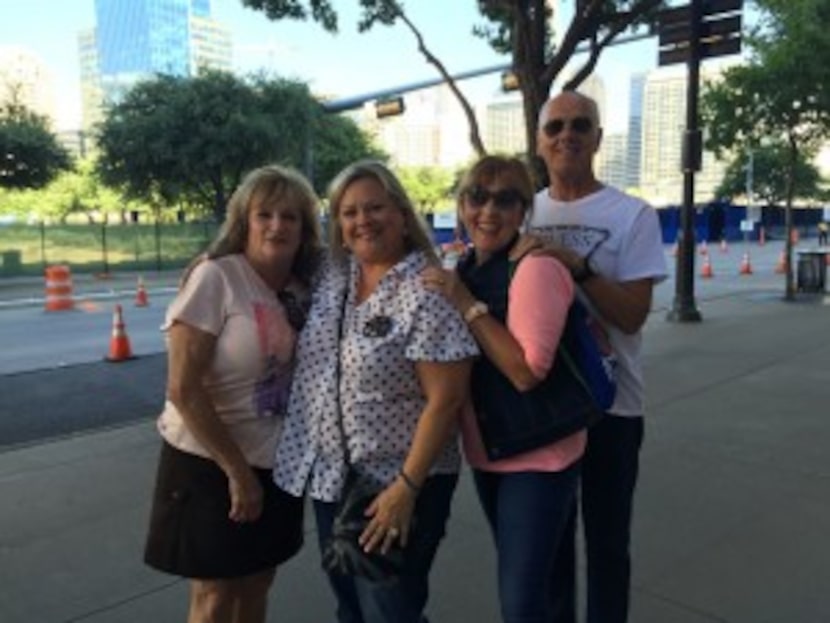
314;474;458;623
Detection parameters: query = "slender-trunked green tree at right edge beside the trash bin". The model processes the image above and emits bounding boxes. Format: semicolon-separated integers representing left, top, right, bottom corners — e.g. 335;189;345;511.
701;0;830;300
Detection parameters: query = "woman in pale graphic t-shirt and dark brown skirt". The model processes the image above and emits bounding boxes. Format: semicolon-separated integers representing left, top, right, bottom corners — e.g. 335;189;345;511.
145;166;320;623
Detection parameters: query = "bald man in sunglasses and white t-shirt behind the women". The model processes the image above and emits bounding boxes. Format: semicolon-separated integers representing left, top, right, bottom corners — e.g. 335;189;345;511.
528;91;666;623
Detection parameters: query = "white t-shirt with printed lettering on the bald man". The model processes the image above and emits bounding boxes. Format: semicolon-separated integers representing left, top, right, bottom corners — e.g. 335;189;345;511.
527;186;667;415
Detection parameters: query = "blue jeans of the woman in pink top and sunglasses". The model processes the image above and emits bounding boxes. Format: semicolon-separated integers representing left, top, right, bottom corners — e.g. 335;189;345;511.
475;463;579;623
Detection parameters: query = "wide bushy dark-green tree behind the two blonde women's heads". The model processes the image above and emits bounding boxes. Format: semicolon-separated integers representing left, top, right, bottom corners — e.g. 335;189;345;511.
98;71;376;221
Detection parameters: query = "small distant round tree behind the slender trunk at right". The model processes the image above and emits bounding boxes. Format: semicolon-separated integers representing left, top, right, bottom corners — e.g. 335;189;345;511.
716;143;822;205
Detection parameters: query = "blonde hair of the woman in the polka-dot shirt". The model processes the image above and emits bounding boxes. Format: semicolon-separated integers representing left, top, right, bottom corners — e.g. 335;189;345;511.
329;160;438;261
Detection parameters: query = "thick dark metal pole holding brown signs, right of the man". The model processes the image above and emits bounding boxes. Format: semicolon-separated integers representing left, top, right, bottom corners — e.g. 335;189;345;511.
666;0;702;322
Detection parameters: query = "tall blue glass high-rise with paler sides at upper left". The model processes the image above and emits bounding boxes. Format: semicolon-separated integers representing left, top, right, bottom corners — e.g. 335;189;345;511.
78;0;232;135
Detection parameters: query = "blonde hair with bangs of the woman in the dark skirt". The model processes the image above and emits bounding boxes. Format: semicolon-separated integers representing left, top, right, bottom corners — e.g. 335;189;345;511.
182;164;323;285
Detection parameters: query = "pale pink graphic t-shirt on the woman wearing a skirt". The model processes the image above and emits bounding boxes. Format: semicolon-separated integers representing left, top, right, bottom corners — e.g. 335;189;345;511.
158;255;297;468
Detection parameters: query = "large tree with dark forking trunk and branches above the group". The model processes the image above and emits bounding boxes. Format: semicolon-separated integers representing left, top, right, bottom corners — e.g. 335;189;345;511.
241;0;664;177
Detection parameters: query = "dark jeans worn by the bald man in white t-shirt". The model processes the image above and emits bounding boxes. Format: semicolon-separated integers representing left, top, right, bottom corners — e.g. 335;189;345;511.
553;416;643;623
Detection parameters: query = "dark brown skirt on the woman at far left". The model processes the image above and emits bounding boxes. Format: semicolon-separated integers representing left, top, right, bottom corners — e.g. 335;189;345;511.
144;442;304;579
